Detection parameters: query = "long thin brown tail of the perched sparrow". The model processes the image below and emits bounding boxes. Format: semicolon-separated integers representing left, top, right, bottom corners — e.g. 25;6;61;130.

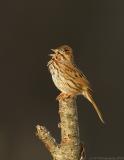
83;90;105;123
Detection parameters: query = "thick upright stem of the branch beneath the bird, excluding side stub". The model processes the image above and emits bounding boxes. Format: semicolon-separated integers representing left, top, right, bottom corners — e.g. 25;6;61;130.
59;97;80;160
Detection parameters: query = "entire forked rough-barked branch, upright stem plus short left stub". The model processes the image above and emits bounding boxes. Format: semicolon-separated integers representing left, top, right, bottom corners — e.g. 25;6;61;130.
36;97;84;160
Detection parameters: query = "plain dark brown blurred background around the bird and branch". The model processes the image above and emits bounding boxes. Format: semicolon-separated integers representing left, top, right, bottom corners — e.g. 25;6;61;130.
0;0;124;160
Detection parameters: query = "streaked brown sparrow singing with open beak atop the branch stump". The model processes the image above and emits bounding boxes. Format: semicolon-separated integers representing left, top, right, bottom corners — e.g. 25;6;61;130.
47;45;104;123
